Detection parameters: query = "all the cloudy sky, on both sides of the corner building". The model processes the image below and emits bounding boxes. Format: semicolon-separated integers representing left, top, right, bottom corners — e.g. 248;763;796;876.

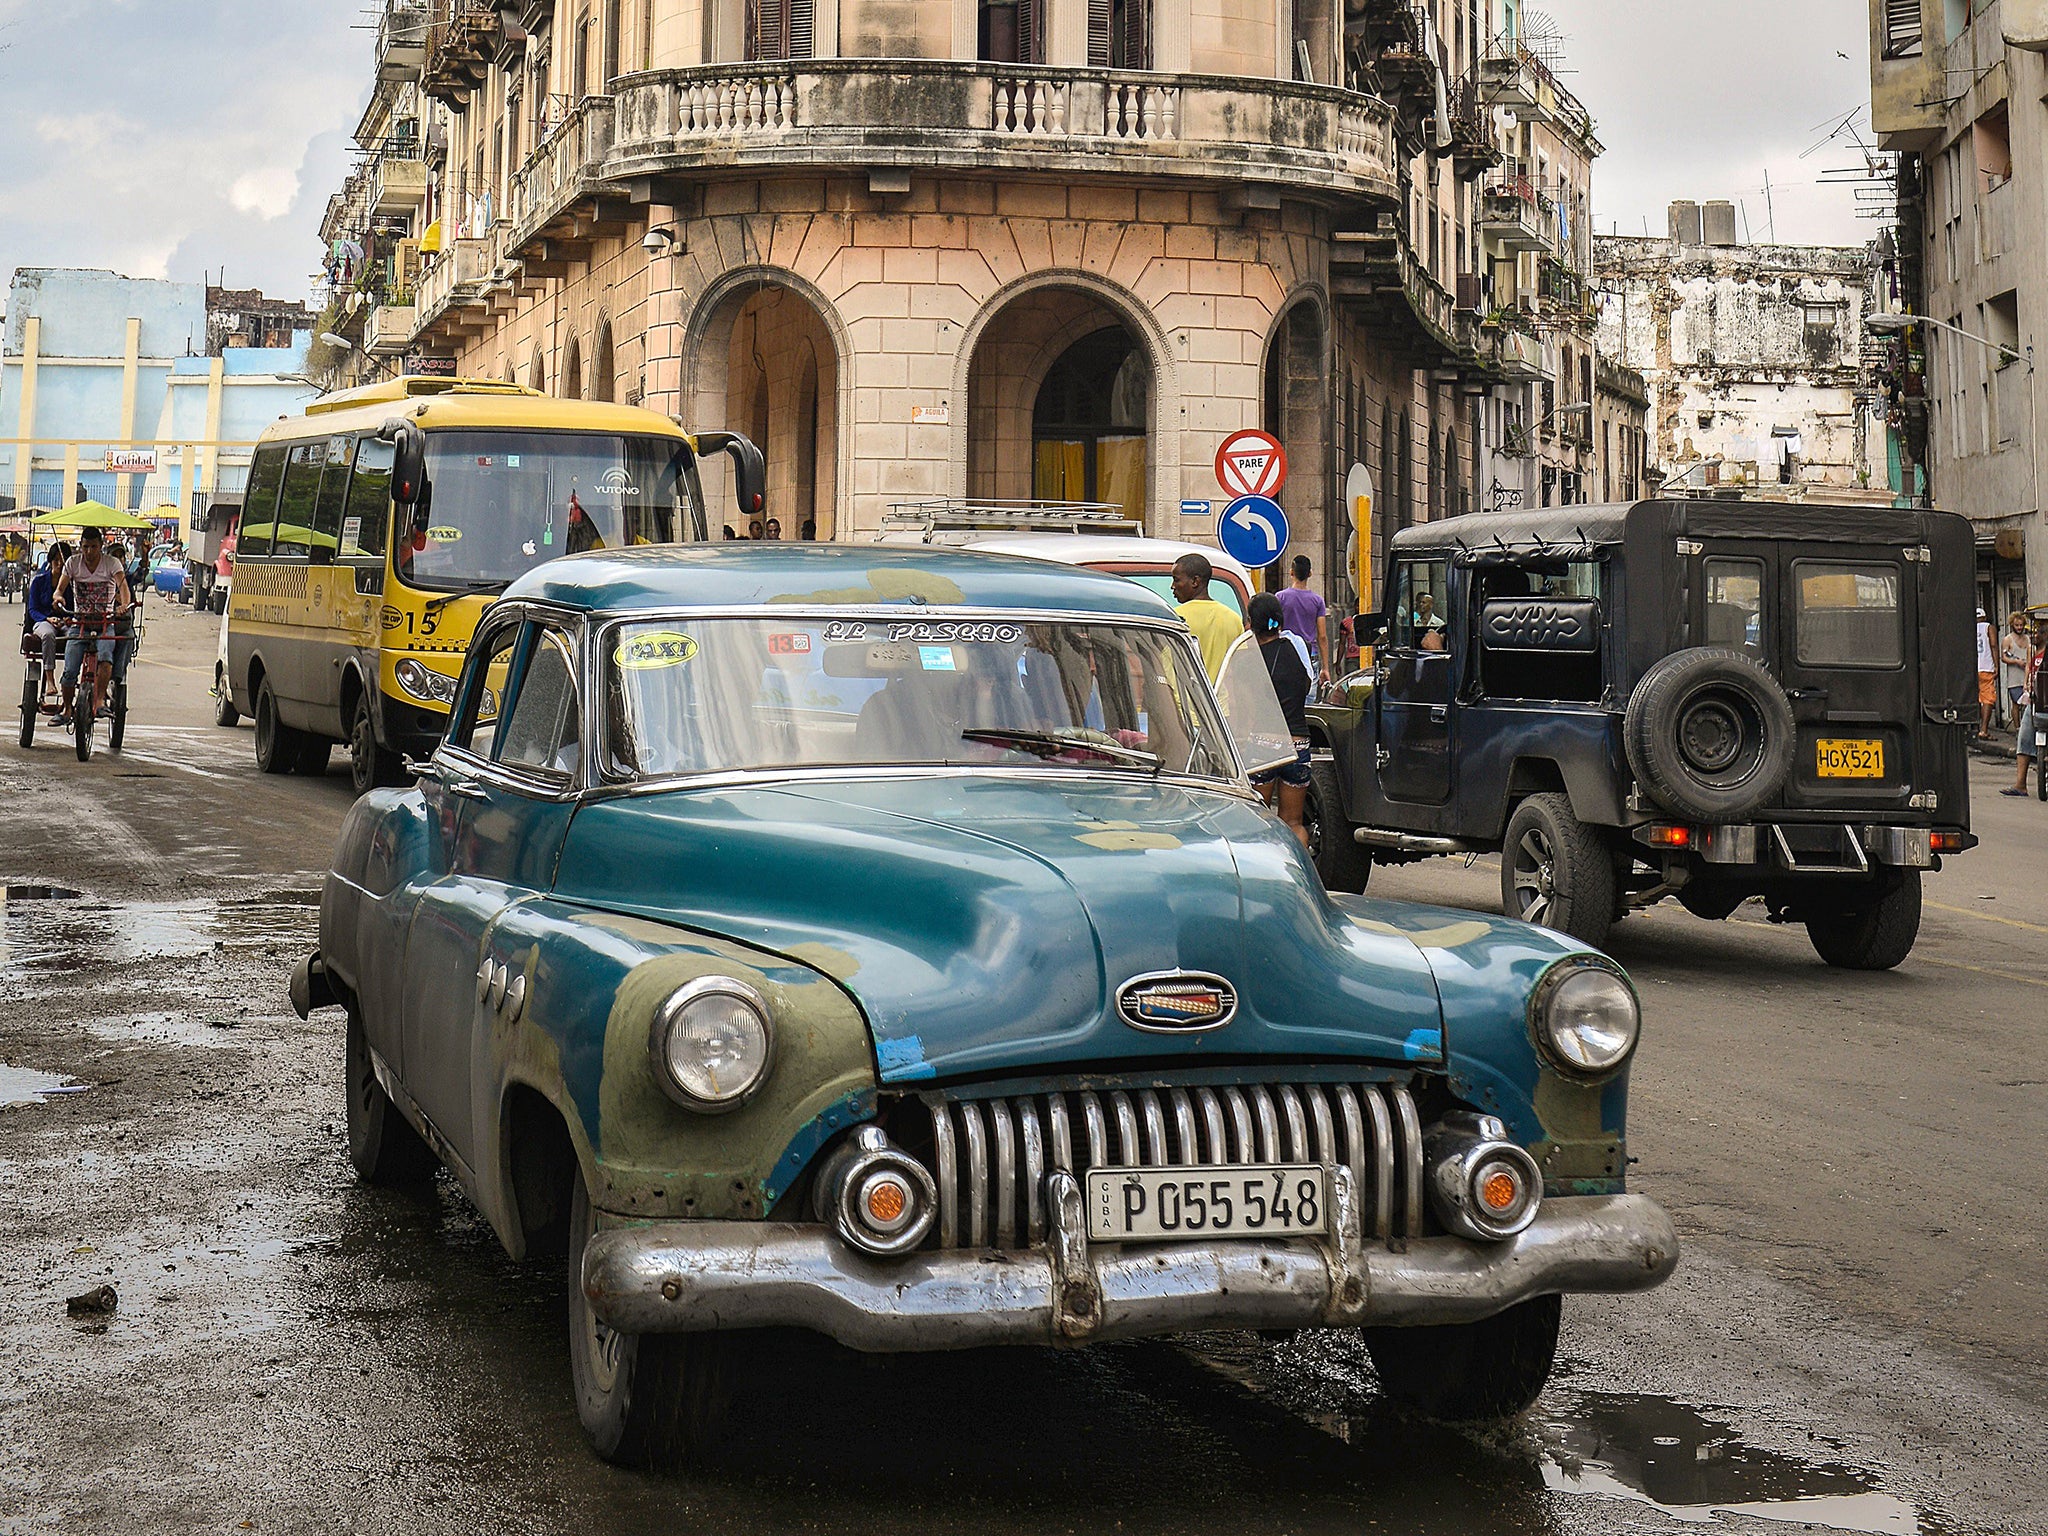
0;0;1872;307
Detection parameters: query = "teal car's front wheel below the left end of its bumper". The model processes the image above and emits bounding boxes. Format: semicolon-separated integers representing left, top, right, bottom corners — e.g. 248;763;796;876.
567;1174;727;1470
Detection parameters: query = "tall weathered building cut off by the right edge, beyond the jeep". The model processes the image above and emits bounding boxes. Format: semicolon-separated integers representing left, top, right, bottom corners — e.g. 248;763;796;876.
1870;0;2048;623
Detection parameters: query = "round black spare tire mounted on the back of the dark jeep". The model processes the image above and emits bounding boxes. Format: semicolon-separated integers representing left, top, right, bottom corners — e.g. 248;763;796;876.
1622;645;1794;821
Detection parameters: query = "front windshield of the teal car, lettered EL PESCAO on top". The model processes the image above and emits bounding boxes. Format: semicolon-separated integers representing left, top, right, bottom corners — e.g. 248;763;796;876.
602;614;1239;778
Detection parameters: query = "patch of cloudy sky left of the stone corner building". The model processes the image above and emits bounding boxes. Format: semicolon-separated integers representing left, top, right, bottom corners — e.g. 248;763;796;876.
0;0;373;297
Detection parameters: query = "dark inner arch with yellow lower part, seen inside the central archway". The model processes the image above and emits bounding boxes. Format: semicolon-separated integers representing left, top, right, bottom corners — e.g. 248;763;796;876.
1032;326;1151;522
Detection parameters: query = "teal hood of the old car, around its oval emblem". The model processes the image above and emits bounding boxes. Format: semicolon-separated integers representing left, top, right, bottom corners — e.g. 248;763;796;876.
555;774;1444;1083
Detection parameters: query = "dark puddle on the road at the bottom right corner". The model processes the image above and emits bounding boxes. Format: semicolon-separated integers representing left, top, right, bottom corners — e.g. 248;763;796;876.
1532;1393;1942;1536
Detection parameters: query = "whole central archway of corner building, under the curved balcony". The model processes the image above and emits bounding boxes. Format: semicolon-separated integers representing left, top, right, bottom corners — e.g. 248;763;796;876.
965;285;1159;524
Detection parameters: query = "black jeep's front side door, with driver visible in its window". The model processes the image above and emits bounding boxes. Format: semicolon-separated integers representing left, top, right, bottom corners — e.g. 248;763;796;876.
1372;555;1458;805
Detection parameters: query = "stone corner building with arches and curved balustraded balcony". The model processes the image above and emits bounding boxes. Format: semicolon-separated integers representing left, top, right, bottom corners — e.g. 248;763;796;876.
324;0;1630;598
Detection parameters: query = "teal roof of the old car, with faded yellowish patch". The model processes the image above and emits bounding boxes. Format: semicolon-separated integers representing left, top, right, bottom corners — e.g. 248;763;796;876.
506;539;1174;618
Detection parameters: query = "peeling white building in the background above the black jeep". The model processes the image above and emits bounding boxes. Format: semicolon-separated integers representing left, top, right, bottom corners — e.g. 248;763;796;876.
1595;214;1892;504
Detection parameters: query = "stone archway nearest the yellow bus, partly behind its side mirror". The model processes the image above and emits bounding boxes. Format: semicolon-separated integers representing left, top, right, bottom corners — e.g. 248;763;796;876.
686;272;840;541
